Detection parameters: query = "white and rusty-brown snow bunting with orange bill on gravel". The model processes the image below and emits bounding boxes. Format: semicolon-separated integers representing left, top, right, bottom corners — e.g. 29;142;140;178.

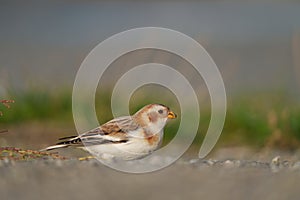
43;104;176;160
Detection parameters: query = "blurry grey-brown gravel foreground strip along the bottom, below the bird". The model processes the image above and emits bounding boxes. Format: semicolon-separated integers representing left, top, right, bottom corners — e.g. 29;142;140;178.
0;157;300;200
